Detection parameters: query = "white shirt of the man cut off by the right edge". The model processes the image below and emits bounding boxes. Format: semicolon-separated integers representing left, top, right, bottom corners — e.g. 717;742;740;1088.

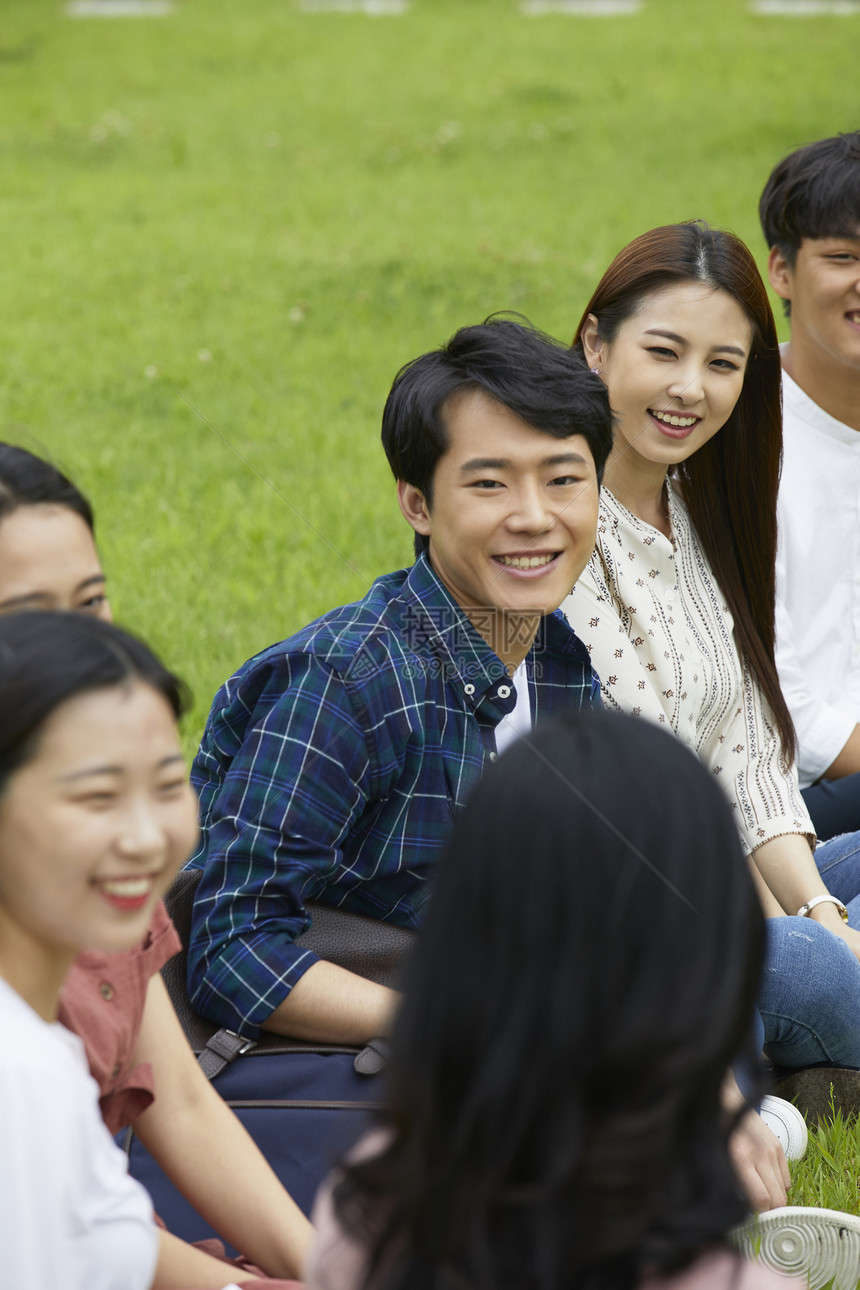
776;372;860;788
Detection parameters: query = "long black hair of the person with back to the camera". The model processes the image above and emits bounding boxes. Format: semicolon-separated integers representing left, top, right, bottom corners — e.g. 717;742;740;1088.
335;712;763;1290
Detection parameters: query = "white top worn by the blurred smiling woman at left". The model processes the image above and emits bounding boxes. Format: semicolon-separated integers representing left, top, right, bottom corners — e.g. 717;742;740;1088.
0;978;159;1290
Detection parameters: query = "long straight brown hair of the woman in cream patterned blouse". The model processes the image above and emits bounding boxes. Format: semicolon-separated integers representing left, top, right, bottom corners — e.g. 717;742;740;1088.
574;221;796;764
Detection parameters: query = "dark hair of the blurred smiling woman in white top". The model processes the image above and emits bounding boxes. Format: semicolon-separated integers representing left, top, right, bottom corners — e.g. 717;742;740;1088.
0;610;187;792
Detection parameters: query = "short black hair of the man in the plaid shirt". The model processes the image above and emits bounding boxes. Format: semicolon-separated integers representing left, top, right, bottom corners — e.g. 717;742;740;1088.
382;315;612;555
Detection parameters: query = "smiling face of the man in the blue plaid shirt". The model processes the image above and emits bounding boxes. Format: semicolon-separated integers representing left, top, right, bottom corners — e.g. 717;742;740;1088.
398;390;598;660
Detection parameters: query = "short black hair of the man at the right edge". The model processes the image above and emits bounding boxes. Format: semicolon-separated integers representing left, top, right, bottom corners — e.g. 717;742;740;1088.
758;130;860;267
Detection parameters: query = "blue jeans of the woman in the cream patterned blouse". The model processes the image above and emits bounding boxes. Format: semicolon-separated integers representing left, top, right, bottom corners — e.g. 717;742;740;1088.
758;833;860;1068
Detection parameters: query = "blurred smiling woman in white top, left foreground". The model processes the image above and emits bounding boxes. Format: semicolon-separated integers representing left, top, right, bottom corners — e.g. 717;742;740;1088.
0;613;195;1290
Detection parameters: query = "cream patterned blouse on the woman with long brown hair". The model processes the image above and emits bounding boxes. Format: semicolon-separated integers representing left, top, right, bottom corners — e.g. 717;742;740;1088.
561;484;815;851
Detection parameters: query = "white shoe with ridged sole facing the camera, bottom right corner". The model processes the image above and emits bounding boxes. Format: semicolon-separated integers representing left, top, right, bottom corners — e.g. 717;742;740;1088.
731;1206;860;1290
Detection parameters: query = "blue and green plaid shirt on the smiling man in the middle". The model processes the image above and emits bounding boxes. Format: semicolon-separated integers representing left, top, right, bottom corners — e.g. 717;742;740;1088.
188;557;600;1035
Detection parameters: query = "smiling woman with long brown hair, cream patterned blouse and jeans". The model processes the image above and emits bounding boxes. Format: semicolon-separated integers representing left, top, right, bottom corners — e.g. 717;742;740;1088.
562;223;860;1088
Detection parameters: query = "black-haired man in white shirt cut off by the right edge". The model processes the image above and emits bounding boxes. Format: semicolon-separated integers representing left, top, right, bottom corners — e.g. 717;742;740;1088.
759;130;860;839
